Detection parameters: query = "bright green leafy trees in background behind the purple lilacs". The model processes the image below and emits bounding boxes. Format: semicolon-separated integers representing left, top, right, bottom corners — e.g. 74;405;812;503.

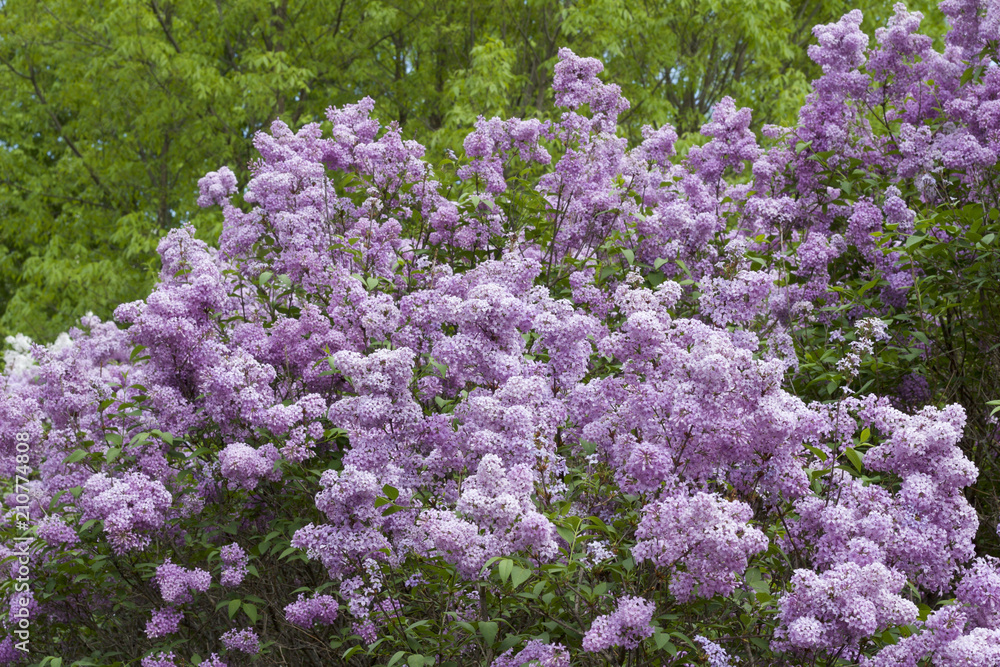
0;0;940;342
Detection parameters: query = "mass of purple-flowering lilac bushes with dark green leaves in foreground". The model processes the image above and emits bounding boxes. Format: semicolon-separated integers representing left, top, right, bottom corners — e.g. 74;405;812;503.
0;0;1000;667
